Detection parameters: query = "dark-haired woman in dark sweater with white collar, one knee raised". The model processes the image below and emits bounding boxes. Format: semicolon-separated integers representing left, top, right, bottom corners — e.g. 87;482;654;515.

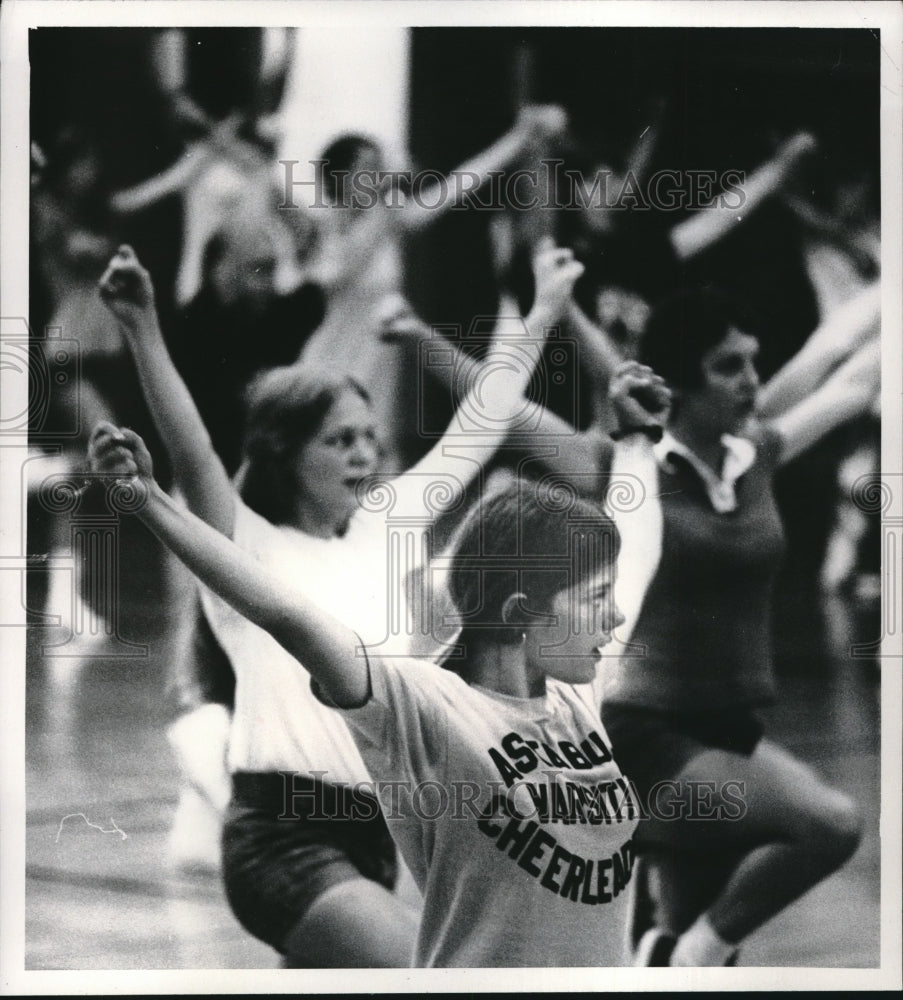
602;286;880;966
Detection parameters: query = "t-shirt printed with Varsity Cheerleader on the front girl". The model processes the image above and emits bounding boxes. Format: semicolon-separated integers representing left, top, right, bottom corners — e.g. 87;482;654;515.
334;658;638;967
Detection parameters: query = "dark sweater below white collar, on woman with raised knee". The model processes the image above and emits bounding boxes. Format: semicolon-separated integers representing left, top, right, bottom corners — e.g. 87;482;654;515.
605;430;784;713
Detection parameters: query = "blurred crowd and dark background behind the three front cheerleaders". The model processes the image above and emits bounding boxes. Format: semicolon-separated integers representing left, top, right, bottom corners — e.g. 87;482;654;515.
30;28;880;600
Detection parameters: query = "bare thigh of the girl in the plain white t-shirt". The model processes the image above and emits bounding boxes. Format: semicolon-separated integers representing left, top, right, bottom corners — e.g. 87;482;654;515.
285;878;418;969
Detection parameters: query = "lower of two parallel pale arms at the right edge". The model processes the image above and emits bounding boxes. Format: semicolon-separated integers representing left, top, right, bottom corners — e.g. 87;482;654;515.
770;338;881;463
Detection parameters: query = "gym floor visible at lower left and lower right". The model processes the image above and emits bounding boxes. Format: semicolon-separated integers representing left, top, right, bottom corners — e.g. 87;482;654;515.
19;528;880;970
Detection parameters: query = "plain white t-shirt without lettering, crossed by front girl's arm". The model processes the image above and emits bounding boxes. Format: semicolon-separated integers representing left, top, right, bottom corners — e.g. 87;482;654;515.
202;496;434;783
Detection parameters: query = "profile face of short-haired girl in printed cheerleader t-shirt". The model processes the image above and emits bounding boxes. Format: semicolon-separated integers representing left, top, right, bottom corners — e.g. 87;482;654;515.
525;562;624;684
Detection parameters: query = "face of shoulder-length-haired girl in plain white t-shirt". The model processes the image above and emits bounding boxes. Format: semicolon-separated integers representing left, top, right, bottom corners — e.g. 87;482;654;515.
296;388;379;536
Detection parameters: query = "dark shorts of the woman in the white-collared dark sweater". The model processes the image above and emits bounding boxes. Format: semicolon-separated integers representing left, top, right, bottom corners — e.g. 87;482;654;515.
602;702;764;802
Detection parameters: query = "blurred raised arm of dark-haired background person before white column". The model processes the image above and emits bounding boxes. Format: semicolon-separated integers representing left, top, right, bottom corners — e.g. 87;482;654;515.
401;105;567;231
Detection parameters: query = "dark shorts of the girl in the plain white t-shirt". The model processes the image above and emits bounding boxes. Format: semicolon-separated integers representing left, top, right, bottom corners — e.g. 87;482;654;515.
223;773;398;953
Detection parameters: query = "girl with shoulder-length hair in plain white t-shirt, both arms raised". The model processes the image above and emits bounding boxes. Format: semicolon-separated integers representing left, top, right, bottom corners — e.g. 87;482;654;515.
93;238;582;967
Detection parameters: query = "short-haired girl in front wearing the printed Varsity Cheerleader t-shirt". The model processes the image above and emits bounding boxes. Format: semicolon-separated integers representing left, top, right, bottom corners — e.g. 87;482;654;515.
92;354;672;967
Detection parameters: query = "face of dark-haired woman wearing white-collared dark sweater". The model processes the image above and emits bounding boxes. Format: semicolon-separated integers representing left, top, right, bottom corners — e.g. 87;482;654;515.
681;328;759;434
